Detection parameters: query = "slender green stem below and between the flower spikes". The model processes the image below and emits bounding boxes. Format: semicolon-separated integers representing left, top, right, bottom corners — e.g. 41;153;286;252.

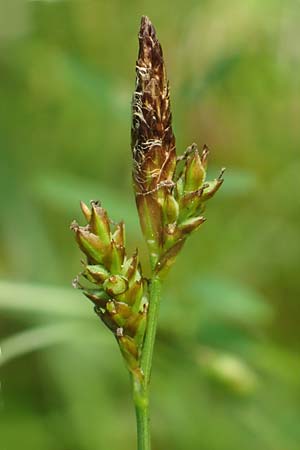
132;276;161;450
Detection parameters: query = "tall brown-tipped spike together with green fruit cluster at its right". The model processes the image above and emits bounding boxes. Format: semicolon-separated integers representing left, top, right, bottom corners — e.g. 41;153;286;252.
131;17;223;271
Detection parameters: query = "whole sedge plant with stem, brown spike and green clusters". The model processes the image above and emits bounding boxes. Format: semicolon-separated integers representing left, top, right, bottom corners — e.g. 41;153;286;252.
71;17;224;450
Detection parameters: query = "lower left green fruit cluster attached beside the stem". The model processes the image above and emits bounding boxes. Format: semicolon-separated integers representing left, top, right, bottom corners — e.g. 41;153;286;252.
71;202;148;377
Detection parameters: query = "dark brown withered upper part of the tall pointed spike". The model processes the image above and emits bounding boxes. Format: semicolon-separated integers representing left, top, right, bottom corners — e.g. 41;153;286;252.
131;16;176;195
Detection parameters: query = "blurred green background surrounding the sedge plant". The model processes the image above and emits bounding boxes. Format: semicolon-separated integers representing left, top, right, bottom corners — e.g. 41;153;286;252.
0;0;300;450
